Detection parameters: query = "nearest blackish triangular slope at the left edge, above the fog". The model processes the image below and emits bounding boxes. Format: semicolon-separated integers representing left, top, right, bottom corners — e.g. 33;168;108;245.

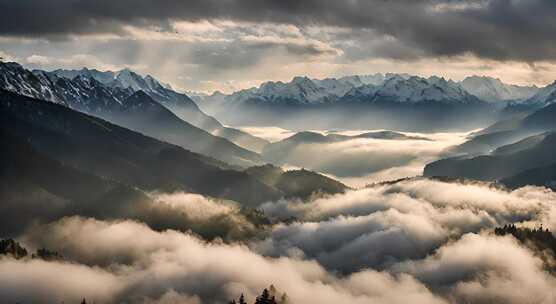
0;130;150;236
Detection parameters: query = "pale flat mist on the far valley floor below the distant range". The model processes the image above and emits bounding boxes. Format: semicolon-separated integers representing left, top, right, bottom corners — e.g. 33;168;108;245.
242;127;471;187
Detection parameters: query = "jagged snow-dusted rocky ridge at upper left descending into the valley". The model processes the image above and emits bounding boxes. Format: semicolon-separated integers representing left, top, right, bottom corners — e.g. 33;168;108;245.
0;63;260;166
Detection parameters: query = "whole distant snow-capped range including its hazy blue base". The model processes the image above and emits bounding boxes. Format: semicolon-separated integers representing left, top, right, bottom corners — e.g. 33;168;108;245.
194;74;553;131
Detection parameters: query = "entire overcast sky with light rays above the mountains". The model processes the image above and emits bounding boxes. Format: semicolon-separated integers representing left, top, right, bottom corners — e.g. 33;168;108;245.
0;0;556;92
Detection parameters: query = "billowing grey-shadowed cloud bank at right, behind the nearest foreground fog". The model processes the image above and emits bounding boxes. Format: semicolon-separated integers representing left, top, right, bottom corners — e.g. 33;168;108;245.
254;179;556;273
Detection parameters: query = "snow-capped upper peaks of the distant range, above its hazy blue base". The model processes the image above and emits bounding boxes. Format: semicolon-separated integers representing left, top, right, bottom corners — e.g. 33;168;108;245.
198;73;540;109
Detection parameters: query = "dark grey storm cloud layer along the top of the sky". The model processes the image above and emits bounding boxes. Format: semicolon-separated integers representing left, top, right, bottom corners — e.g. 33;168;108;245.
0;0;556;62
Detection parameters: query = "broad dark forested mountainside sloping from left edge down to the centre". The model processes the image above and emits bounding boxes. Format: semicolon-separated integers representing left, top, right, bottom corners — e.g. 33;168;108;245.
0;90;346;220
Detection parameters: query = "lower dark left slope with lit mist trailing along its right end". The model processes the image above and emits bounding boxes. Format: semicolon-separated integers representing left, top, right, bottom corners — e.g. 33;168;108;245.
0;130;274;240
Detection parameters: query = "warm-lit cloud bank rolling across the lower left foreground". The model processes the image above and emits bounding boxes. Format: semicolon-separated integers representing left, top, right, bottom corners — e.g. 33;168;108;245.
6;217;445;303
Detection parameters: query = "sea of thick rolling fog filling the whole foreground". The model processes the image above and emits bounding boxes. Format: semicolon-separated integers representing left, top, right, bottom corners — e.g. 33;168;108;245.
6;178;556;304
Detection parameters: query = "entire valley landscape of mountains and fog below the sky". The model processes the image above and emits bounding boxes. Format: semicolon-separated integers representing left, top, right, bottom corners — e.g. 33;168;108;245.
0;62;556;304
